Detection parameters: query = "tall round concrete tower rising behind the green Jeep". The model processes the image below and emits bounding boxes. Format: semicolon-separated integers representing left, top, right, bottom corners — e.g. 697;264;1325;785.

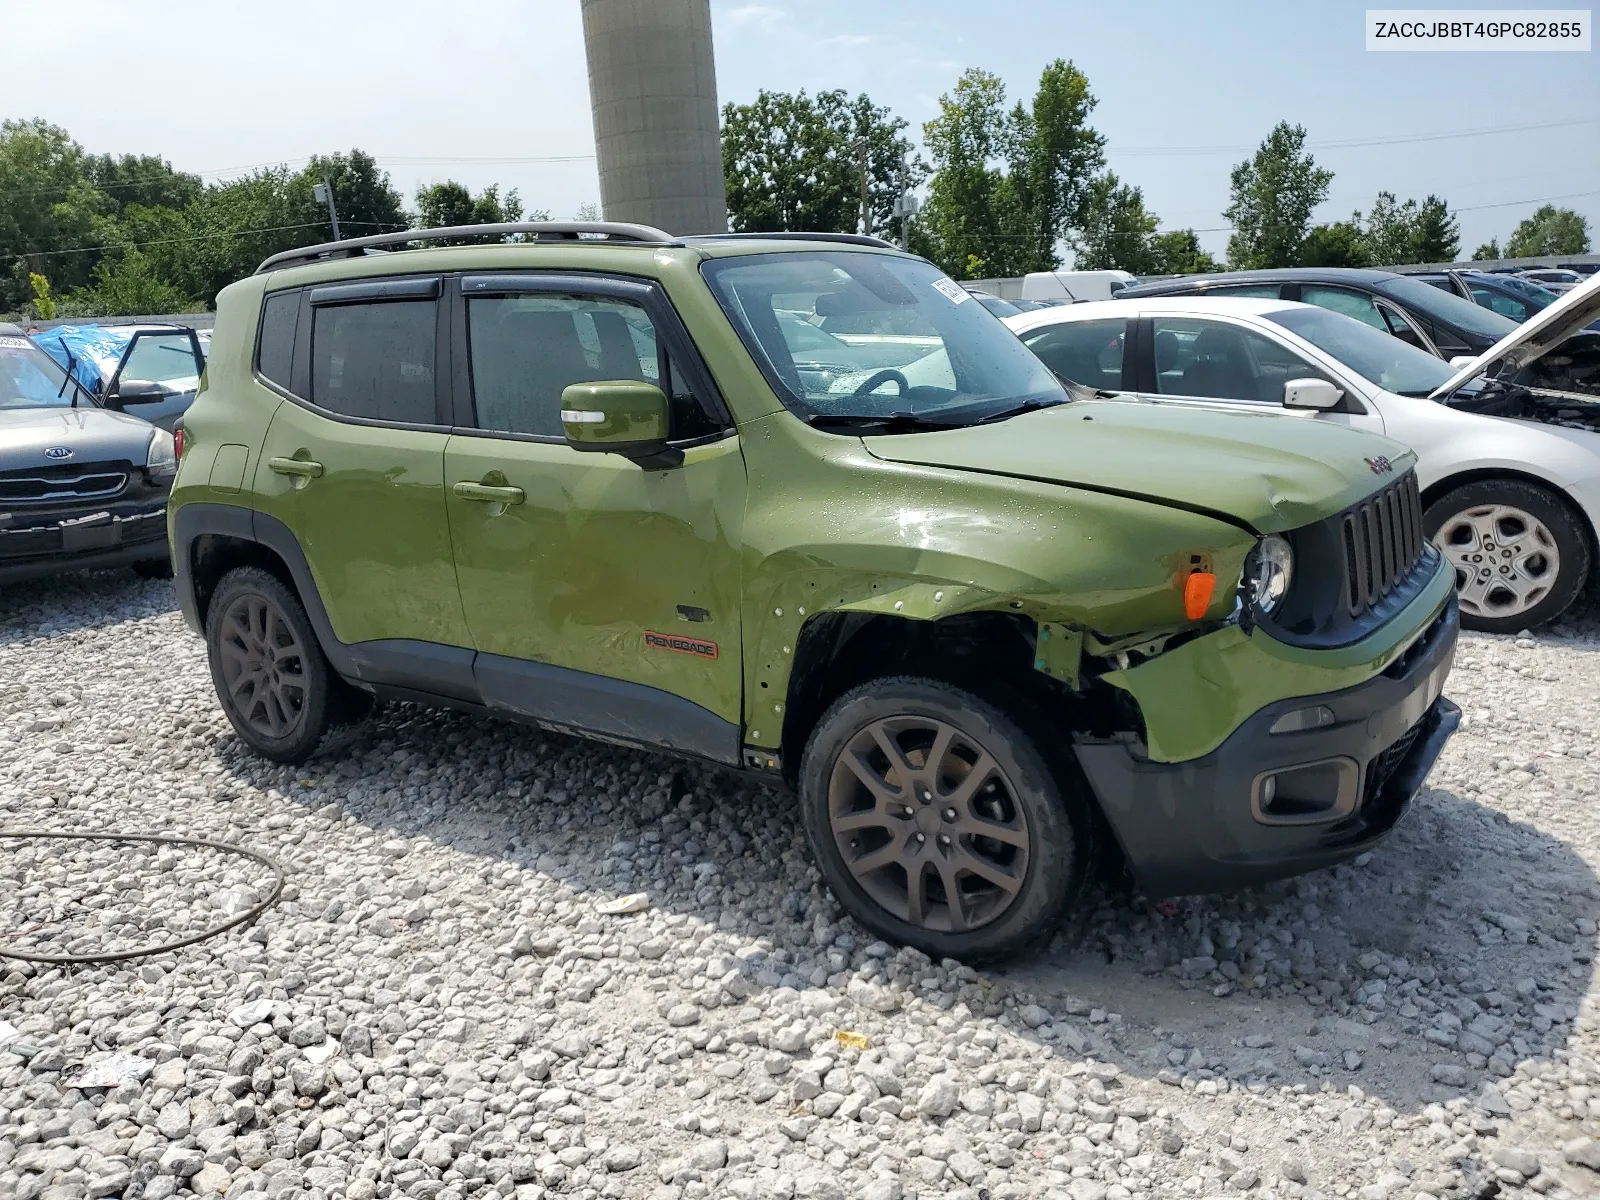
582;0;728;234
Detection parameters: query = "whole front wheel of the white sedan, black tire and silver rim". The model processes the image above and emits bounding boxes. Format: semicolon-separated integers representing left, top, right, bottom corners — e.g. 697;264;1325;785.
1422;480;1590;634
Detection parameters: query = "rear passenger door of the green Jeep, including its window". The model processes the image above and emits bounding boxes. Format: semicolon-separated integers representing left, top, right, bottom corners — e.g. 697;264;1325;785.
254;275;470;659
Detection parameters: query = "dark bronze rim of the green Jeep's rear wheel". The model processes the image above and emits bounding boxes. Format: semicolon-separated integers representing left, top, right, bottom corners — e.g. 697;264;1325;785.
218;592;307;739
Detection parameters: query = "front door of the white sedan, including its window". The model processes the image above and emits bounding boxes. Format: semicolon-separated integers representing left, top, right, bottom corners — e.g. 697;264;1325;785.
1139;312;1382;434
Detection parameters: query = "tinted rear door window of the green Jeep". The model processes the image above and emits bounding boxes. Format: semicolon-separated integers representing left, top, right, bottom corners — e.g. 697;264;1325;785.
310;299;438;426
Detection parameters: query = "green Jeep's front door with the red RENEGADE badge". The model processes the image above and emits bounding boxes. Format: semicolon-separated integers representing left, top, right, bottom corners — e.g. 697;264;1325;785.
445;272;746;762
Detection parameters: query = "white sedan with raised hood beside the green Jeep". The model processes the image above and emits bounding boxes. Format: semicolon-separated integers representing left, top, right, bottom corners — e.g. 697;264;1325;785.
1005;278;1600;634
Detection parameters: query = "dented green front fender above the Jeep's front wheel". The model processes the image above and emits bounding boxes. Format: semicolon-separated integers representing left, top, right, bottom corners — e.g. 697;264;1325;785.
741;414;1254;747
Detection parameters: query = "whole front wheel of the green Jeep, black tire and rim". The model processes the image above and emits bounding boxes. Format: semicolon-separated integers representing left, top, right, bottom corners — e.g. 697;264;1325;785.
798;675;1094;962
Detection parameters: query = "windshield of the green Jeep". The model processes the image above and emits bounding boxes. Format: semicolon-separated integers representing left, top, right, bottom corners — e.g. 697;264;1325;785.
702;251;1067;424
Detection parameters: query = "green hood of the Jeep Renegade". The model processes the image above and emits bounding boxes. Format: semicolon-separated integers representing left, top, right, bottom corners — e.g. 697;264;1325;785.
862;400;1416;533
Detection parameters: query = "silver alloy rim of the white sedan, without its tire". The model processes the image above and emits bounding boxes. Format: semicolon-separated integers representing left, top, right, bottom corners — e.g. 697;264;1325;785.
1434;504;1562;618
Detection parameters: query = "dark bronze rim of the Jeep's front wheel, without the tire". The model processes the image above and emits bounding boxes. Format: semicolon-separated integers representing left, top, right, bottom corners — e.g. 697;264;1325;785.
827;715;1030;933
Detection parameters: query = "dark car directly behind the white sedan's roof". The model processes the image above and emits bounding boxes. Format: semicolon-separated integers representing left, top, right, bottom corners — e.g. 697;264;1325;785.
1117;267;1518;358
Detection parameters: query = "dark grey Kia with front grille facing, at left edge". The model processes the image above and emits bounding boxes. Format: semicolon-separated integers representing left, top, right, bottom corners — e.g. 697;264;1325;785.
0;325;178;584
